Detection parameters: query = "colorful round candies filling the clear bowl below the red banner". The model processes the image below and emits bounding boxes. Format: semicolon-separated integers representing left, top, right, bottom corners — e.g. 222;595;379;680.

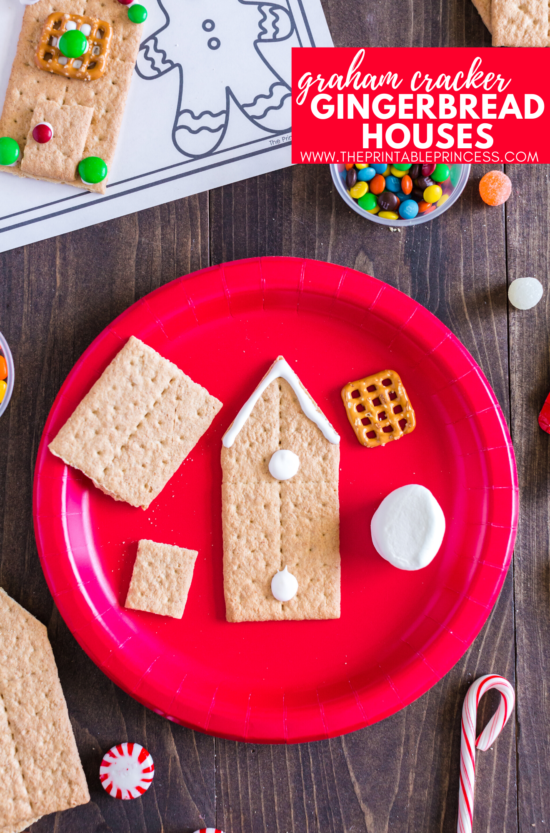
342;162;461;220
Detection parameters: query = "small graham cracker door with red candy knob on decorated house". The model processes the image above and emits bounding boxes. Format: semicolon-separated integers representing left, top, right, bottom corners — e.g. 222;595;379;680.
21;101;94;181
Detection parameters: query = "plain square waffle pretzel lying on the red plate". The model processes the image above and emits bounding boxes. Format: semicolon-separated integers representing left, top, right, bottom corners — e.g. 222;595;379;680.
342;370;416;448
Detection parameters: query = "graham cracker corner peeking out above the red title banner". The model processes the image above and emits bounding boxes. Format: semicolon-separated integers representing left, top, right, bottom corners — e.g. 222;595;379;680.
491;0;549;46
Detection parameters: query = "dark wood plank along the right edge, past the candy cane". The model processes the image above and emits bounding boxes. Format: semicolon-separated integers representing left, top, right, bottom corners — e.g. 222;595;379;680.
506;165;550;833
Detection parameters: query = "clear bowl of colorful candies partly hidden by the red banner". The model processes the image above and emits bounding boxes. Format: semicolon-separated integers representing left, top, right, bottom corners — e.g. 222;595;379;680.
330;162;471;227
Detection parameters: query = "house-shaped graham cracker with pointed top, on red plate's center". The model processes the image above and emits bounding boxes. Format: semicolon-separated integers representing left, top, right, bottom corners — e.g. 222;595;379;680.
222;379;340;622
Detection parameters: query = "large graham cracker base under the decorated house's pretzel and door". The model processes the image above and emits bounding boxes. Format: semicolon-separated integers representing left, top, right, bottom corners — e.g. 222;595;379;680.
0;0;143;194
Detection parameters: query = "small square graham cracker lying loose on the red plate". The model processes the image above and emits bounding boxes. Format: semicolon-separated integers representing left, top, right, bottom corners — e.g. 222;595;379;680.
124;540;198;619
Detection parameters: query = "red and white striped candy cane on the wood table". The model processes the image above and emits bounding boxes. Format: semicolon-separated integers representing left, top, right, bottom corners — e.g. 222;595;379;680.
457;674;516;833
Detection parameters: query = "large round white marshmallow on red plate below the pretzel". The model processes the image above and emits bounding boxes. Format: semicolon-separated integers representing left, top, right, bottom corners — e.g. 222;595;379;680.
371;484;445;570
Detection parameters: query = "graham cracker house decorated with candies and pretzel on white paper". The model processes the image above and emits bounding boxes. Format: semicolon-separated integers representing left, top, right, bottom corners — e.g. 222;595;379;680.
0;0;147;193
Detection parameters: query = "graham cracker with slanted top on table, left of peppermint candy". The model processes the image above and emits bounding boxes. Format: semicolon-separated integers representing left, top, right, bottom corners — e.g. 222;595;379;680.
0;589;90;833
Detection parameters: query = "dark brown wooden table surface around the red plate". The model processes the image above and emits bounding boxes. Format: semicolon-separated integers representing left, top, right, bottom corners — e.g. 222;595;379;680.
0;0;550;833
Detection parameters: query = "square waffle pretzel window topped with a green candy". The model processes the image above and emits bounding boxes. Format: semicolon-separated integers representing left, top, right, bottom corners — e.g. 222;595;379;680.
34;12;113;81
